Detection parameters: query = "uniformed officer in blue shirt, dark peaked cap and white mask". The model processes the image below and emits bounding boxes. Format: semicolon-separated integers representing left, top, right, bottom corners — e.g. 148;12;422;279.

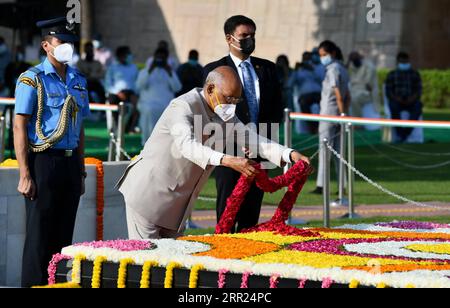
14;17;89;287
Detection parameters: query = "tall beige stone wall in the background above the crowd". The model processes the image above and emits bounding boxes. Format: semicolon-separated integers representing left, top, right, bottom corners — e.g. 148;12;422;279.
95;0;414;66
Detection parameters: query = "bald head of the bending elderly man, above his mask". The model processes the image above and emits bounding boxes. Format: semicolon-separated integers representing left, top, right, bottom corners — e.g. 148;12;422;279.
204;66;242;103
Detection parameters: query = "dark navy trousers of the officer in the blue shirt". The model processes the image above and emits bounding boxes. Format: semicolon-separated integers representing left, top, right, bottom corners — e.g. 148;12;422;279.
22;151;82;287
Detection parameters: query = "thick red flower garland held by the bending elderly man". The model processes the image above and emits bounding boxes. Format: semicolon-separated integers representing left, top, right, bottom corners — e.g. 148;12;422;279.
216;161;316;236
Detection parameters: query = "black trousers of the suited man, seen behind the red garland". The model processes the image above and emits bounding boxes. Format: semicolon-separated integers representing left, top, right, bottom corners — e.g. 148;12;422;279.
215;167;264;232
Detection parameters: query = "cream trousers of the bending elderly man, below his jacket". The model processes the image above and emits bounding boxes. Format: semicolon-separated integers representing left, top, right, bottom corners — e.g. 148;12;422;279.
126;205;183;240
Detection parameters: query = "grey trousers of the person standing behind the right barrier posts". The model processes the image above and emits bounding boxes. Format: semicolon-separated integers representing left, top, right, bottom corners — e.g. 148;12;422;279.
317;122;346;187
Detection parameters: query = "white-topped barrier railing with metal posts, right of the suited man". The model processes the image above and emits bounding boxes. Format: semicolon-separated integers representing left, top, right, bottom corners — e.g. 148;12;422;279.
284;109;450;228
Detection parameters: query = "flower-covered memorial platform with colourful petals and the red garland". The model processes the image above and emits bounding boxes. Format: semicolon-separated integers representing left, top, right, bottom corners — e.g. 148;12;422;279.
48;162;450;288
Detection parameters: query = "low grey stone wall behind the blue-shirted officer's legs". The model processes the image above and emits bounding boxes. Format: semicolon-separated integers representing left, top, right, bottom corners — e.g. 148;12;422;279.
0;163;128;287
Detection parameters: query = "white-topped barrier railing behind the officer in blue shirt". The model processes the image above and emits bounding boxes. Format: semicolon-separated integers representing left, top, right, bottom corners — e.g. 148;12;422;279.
0;97;126;162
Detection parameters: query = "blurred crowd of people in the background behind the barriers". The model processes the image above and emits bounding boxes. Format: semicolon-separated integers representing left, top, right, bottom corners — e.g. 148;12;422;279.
0;37;422;145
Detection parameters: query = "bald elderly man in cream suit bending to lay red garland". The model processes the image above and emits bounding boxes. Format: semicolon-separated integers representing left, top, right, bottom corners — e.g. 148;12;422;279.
118;67;309;239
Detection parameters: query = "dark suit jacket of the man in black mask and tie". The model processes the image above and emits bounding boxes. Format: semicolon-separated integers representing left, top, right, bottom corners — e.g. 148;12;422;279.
204;56;285;126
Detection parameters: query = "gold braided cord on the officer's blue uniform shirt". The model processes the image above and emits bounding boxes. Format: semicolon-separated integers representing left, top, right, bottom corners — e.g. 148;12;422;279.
30;76;78;153
